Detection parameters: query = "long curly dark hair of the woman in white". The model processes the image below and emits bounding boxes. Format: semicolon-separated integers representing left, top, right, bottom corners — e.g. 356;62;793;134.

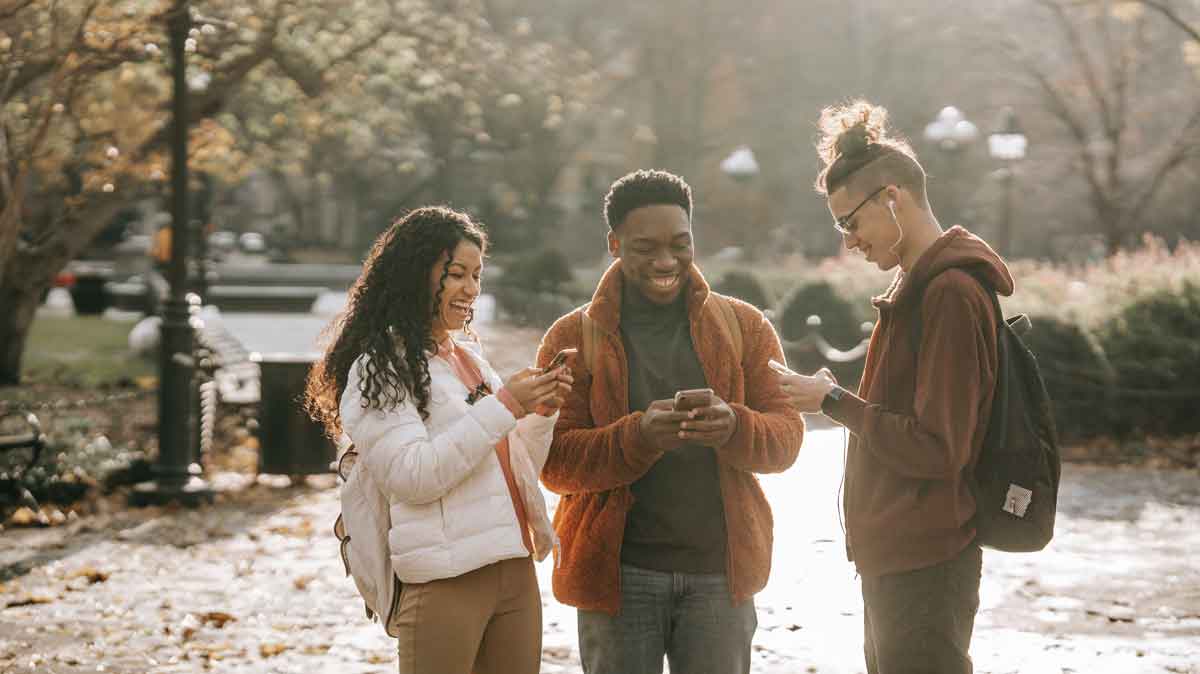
304;206;487;441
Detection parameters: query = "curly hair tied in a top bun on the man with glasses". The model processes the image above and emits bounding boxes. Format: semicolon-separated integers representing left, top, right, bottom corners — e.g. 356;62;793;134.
815;101;925;201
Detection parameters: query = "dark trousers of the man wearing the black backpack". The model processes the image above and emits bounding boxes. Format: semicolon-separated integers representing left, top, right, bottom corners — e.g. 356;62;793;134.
863;543;983;674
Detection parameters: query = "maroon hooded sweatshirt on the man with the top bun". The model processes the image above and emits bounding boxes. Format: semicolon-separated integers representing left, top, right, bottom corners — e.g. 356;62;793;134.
829;227;1013;576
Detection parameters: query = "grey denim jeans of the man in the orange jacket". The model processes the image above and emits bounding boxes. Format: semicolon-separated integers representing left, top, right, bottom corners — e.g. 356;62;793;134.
578;565;758;674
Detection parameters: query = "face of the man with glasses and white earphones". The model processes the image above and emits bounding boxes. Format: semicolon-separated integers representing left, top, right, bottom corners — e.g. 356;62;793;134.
829;186;904;271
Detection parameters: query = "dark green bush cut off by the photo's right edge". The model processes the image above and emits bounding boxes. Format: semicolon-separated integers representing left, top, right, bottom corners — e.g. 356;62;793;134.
1099;281;1200;434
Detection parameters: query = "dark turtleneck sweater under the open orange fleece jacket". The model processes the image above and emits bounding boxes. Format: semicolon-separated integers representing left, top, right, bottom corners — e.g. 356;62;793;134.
620;287;727;573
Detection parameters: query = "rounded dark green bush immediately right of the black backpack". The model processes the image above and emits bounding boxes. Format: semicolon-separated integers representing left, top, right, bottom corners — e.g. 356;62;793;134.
1024;315;1116;441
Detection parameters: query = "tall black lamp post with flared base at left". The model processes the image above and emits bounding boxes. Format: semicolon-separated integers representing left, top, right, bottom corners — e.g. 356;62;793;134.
130;0;212;505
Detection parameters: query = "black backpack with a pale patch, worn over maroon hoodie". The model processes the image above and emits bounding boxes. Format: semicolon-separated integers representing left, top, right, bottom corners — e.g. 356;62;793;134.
913;270;1062;553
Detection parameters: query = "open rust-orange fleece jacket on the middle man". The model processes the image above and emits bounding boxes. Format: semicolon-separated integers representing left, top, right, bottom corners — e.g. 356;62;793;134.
538;260;804;614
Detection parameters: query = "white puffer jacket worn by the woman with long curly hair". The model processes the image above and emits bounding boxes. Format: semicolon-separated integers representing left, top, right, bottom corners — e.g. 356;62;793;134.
341;341;558;583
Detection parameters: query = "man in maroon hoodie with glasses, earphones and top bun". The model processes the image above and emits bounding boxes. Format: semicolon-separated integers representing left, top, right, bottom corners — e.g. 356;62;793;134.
781;101;1013;674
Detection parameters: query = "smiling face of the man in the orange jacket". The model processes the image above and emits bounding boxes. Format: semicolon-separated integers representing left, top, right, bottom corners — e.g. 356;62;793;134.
608;204;695;305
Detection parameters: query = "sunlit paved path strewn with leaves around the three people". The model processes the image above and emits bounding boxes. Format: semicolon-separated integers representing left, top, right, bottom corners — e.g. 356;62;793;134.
0;431;1200;674
